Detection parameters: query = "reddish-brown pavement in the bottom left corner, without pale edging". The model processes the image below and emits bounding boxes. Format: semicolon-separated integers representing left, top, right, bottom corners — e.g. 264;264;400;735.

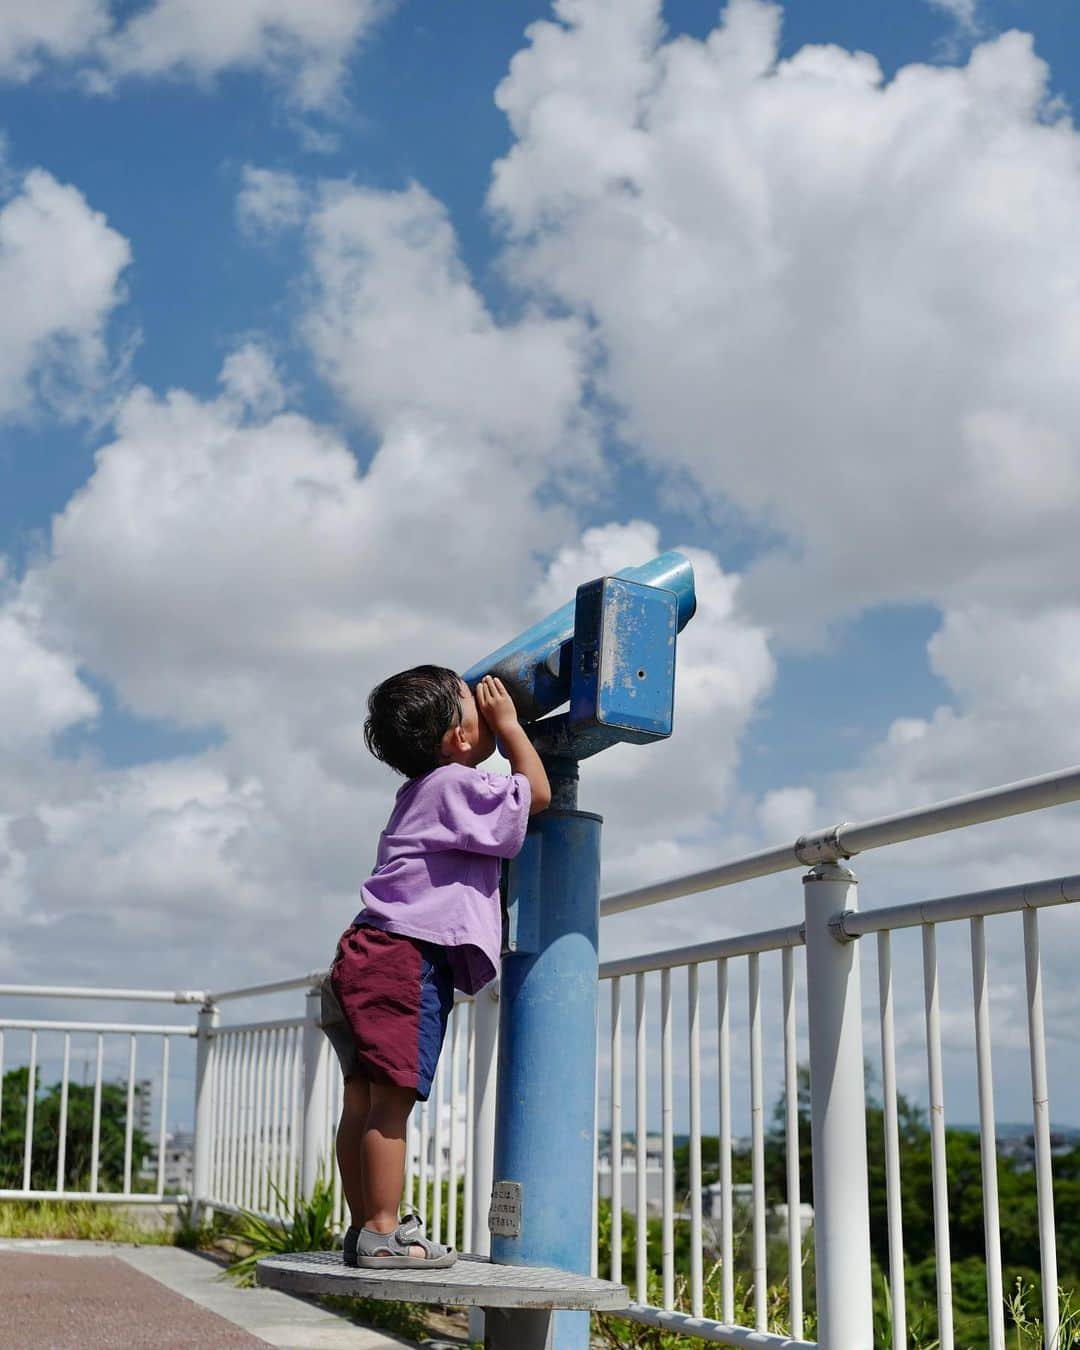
0;1251;267;1350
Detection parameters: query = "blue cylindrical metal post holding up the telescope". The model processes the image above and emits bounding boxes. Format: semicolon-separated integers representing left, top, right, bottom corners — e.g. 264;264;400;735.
487;759;602;1350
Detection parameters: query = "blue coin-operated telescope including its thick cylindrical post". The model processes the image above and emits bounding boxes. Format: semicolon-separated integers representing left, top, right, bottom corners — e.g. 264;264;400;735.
464;554;697;1350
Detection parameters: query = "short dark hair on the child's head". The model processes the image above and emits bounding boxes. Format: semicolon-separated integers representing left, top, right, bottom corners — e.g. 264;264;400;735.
363;666;462;778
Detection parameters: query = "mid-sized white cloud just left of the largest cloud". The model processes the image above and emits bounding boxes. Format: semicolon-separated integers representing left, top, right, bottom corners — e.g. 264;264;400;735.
305;185;593;475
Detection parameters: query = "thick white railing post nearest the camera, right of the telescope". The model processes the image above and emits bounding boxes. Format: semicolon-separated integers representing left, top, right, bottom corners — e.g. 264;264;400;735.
803;863;873;1350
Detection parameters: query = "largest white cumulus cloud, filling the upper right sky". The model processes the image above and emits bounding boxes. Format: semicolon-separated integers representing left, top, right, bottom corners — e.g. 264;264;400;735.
490;0;1080;628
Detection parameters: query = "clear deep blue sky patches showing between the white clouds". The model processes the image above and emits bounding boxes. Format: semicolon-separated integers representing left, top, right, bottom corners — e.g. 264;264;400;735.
0;0;1009;790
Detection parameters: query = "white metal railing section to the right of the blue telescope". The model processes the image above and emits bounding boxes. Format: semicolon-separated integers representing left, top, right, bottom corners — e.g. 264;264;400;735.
591;768;1080;1350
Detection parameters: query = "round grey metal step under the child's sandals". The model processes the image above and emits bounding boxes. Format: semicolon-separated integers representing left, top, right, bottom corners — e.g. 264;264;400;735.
257;1251;630;1312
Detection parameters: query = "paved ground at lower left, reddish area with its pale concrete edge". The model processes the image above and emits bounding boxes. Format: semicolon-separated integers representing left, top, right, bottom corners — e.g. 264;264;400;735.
0;1238;426;1350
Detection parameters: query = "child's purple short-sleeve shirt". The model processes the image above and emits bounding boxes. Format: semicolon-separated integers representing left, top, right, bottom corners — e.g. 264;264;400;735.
355;764;532;994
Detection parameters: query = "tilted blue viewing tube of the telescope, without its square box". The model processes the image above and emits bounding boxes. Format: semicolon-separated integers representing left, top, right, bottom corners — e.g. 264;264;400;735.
463;552;698;738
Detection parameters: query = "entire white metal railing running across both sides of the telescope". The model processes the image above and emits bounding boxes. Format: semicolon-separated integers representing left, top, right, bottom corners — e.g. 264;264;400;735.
0;768;1080;1350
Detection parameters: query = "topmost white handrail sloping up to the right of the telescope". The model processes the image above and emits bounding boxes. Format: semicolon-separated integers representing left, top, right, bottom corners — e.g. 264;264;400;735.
599;767;1080;918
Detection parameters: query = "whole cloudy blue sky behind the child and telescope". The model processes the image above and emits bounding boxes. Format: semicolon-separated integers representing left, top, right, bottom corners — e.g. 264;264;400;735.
0;0;1080;1128
